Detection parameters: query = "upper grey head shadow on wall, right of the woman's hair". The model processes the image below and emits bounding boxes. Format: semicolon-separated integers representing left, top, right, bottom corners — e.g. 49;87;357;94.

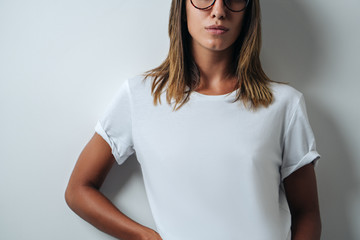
261;0;321;84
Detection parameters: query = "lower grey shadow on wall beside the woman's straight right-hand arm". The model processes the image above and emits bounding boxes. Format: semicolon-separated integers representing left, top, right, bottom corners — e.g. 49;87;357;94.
307;98;358;240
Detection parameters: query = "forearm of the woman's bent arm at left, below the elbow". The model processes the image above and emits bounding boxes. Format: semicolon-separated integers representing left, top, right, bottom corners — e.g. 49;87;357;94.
67;186;149;240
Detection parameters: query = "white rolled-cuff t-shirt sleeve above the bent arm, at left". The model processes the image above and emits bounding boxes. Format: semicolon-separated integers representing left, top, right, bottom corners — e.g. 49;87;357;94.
95;80;135;165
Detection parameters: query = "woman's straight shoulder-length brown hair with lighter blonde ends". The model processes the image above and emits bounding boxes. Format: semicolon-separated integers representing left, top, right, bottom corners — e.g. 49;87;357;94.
143;0;284;111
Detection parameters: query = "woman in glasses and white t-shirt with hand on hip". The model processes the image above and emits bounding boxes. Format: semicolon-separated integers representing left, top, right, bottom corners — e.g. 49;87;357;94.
65;0;321;240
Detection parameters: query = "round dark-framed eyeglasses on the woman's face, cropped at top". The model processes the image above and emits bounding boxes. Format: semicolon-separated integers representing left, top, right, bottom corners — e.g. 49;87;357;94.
190;0;250;12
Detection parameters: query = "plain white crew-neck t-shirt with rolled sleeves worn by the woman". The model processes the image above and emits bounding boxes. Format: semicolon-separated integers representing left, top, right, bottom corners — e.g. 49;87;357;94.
95;75;320;240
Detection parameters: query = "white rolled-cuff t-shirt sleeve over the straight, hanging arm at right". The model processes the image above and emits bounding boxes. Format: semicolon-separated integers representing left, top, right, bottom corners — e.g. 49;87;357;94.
280;94;321;181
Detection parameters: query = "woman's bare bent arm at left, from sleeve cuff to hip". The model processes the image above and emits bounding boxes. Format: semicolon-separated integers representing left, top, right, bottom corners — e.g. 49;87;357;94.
65;133;162;240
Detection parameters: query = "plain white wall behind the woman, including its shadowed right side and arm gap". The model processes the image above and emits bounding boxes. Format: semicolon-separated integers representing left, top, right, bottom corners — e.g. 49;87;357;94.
0;0;360;240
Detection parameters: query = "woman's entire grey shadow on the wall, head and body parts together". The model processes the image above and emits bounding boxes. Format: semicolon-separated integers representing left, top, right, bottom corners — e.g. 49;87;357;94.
261;0;358;240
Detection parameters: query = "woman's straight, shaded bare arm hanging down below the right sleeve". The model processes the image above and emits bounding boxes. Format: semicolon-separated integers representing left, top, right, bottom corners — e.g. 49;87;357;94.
284;163;321;240
